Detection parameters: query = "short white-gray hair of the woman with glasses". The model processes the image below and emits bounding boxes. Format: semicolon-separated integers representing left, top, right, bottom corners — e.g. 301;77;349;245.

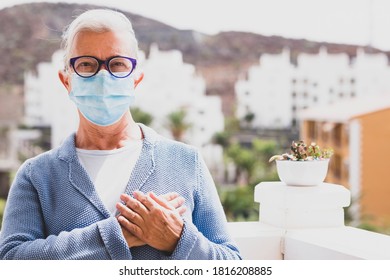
62;9;138;69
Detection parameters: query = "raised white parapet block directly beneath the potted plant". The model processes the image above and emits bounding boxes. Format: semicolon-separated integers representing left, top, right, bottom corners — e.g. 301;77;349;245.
255;182;351;229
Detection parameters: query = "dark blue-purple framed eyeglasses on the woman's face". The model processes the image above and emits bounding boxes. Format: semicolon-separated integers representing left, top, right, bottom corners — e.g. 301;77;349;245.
70;56;137;78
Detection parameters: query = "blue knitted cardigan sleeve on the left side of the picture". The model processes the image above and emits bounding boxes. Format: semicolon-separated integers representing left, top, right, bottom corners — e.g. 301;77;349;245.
0;162;131;260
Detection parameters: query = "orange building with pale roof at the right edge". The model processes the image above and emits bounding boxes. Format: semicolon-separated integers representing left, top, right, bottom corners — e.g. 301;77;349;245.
300;95;390;228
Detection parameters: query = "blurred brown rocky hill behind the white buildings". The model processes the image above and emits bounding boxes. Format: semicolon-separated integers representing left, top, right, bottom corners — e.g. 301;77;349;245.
0;3;386;115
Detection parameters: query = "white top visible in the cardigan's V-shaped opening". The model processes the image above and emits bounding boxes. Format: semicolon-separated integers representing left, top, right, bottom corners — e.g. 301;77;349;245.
76;140;142;215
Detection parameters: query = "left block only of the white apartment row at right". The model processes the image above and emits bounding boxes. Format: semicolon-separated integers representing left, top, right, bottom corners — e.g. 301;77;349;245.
235;49;293;128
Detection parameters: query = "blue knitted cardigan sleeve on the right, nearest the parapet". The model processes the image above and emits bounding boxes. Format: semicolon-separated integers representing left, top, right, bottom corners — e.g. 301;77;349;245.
164;153;241;260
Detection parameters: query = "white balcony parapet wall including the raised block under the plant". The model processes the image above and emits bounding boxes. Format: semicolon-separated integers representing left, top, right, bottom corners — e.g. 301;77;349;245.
229;182;390;260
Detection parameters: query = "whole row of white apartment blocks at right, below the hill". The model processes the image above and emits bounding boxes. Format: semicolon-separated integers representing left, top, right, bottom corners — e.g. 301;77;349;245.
236;48;390;128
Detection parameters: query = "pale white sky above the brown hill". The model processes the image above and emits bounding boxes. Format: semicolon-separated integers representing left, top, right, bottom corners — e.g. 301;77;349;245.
0;0;390;51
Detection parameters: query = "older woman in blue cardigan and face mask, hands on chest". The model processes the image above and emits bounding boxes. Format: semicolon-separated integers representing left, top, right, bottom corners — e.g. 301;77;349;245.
0;9;241;259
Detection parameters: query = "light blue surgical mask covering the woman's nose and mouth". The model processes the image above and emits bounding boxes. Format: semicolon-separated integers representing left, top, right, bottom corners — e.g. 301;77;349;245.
69;70;134;126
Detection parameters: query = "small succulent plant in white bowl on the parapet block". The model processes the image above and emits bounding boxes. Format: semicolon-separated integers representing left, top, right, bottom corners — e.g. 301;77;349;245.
269;140;333;186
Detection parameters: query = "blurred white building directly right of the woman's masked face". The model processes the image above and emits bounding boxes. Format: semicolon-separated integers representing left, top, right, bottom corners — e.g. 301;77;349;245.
134;45;224;147
